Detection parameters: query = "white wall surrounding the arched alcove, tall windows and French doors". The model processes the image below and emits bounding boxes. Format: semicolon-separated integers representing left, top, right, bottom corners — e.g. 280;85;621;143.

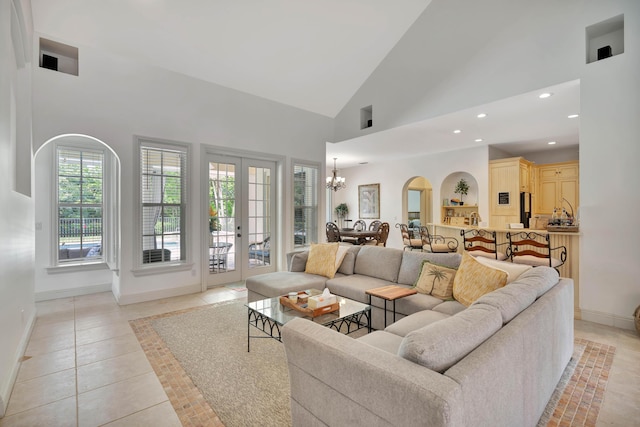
33;34;333;302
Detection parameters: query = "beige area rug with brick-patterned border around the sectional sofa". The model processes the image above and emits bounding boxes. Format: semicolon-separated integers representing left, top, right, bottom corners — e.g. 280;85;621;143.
130;301;615;427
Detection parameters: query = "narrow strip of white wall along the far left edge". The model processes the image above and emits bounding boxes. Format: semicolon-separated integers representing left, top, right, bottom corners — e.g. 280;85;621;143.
0;0;35;416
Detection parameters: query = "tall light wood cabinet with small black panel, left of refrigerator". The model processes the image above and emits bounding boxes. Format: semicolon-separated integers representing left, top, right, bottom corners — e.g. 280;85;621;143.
489;157;534;228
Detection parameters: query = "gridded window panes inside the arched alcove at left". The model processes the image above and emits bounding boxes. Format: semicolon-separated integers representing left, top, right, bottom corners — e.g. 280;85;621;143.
56;150;104;264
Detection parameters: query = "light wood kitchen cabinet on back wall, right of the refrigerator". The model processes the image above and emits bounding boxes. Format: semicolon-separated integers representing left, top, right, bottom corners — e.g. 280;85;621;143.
534;161;580;215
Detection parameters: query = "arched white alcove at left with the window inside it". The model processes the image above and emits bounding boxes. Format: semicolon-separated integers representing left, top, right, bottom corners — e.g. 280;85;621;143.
34;134;121;300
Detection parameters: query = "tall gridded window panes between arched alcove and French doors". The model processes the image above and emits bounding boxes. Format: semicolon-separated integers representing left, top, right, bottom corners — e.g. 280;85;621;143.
140;141;188;264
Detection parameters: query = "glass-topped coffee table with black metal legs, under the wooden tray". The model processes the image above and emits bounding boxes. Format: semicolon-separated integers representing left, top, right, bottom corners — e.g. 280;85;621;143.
245;289;371;351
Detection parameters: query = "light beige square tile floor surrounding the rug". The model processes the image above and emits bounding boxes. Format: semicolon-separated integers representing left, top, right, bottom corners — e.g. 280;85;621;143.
0;287;640;427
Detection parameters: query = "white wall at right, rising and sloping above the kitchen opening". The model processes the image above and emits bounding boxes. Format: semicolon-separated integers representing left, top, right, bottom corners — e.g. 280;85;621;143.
334;0;640;328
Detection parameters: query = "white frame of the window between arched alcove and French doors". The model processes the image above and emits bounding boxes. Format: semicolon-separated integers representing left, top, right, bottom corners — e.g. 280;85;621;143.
132;137;193;276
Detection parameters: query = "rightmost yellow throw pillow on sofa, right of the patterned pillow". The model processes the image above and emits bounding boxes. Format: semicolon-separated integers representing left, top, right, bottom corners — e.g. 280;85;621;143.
453;252;507;307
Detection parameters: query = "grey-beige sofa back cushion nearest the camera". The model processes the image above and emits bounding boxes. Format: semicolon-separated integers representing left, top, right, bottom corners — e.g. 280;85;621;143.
398;304;502;373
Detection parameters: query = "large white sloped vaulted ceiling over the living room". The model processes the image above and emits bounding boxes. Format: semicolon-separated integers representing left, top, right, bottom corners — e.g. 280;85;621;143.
31;0;431;117
